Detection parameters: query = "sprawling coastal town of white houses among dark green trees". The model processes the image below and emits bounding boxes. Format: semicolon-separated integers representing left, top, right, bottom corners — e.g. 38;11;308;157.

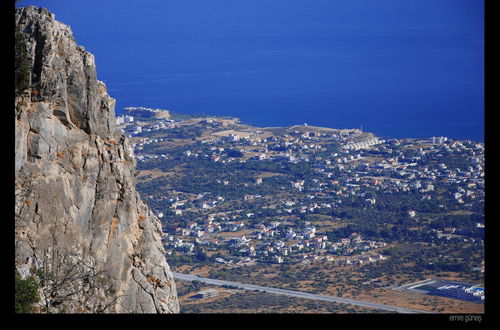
118;110;484;314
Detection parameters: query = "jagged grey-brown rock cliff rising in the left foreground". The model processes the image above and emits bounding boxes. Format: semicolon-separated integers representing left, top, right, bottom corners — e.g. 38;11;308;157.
15;6;179;313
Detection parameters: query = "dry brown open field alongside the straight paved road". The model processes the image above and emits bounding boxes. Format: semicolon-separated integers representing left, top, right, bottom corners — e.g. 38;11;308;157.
169;255;484;313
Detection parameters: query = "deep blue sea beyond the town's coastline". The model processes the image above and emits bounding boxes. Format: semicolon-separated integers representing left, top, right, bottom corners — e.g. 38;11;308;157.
18;0;484;141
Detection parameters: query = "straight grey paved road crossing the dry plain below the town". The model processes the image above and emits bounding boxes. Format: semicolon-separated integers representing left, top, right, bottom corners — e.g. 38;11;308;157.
172;272;432;314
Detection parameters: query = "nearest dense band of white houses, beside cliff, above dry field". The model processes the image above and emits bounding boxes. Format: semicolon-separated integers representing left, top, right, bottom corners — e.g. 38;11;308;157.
164;211;386;265
